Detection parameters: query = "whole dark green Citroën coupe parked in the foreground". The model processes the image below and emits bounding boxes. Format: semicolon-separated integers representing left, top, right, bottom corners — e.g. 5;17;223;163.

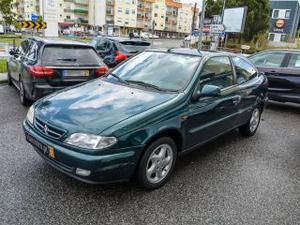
23;49;267;189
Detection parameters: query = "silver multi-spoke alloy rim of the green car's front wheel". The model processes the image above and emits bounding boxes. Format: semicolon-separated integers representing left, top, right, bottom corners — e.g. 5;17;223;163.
146;144;174;184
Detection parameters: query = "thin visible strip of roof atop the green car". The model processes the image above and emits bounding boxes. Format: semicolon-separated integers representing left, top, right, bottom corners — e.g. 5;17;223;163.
146;48;238;58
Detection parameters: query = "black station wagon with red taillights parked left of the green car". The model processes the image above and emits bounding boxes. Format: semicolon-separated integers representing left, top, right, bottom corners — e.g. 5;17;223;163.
7;38;108;105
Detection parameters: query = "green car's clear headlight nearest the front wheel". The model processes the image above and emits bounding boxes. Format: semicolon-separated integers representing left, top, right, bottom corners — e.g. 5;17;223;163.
65;133;117;150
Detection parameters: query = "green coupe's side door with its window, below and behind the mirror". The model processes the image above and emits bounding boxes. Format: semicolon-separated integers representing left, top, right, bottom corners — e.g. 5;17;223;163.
184;56;241;148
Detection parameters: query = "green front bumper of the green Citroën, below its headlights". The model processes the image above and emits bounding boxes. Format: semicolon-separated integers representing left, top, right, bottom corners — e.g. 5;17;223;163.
23;121;143;184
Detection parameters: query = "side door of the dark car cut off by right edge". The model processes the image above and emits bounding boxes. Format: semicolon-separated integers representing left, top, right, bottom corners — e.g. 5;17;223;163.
269;53;300;95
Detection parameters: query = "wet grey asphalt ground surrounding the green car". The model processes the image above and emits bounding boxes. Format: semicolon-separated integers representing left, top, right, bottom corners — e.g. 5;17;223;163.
0;86;300;225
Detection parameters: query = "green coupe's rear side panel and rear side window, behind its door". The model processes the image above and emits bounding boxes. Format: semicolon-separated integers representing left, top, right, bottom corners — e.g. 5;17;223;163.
232;56;261;125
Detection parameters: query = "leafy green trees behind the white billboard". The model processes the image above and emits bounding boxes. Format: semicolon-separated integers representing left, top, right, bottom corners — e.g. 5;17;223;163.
206;0;270;41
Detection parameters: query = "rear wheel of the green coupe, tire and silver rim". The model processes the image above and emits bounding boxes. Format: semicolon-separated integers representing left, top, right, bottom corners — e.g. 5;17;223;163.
239;106;261;137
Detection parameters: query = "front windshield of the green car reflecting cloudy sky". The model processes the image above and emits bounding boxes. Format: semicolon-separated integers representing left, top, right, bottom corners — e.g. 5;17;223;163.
109;52;201;91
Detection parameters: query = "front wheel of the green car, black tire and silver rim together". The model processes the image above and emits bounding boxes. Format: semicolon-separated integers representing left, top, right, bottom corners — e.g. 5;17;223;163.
137;137;177;190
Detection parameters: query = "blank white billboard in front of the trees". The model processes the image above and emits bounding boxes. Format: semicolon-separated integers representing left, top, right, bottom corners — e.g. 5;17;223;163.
223;7;248;33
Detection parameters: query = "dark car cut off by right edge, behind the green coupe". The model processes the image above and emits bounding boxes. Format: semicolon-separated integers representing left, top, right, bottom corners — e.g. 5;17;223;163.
249;49;300;103
